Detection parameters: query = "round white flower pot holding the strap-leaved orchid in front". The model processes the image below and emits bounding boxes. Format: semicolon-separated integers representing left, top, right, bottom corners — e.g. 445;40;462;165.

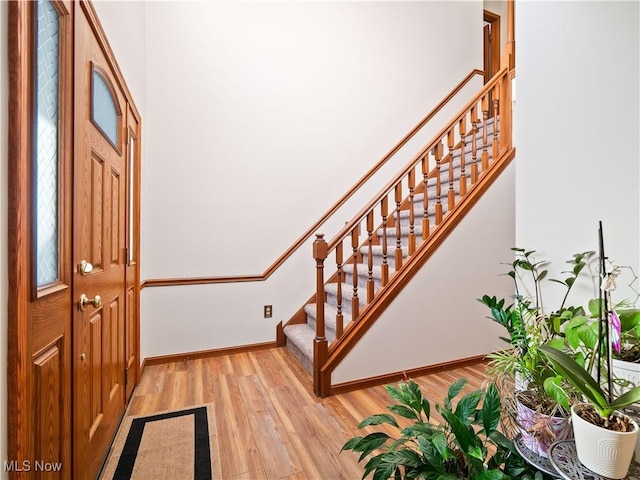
571;403;638;479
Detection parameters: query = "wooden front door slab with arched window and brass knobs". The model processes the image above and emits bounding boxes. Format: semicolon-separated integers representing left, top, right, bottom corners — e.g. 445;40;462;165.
73;5;127;479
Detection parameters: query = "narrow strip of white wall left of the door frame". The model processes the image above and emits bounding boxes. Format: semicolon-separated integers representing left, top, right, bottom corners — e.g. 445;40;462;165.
0;2;9;479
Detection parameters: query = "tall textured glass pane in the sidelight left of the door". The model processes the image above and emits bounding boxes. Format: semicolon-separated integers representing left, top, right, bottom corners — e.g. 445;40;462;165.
35;0;60;287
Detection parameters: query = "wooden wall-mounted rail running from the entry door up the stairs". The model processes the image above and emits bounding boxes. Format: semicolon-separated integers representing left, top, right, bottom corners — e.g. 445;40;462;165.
142;68;484;288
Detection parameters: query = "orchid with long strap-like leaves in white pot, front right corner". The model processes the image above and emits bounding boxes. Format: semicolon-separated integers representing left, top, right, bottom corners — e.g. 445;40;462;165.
540;346;640;479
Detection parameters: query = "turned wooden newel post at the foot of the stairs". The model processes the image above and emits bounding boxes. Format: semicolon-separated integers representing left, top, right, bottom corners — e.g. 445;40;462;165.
313;233;329;397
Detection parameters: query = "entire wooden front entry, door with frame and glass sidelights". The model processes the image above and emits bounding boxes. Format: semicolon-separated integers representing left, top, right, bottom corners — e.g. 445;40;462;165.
7;0;140;480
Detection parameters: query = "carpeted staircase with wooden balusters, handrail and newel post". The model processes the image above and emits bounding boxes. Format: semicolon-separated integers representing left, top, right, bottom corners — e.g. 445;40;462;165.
278;66;515;396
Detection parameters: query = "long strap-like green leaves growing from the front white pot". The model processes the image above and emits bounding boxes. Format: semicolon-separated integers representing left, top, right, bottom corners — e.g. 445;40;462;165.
540;346;640;419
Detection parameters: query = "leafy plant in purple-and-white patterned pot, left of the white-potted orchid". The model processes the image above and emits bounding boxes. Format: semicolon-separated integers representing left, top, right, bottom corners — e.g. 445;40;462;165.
478;248;594;457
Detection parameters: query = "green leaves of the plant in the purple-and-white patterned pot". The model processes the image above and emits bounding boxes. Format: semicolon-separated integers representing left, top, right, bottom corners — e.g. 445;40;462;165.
478;248;597;414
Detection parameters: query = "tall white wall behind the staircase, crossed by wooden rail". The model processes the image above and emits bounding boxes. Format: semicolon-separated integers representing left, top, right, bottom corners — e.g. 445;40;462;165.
141;2;482;358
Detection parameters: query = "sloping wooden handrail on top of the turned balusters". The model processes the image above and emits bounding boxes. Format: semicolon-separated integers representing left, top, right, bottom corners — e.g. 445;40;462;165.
327;67;509;255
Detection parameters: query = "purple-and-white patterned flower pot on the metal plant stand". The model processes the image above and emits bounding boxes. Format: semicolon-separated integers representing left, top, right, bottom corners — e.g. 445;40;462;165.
516;394;572;458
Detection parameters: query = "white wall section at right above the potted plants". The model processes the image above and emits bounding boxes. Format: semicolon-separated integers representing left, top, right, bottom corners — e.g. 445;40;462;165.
514;1;640;303
